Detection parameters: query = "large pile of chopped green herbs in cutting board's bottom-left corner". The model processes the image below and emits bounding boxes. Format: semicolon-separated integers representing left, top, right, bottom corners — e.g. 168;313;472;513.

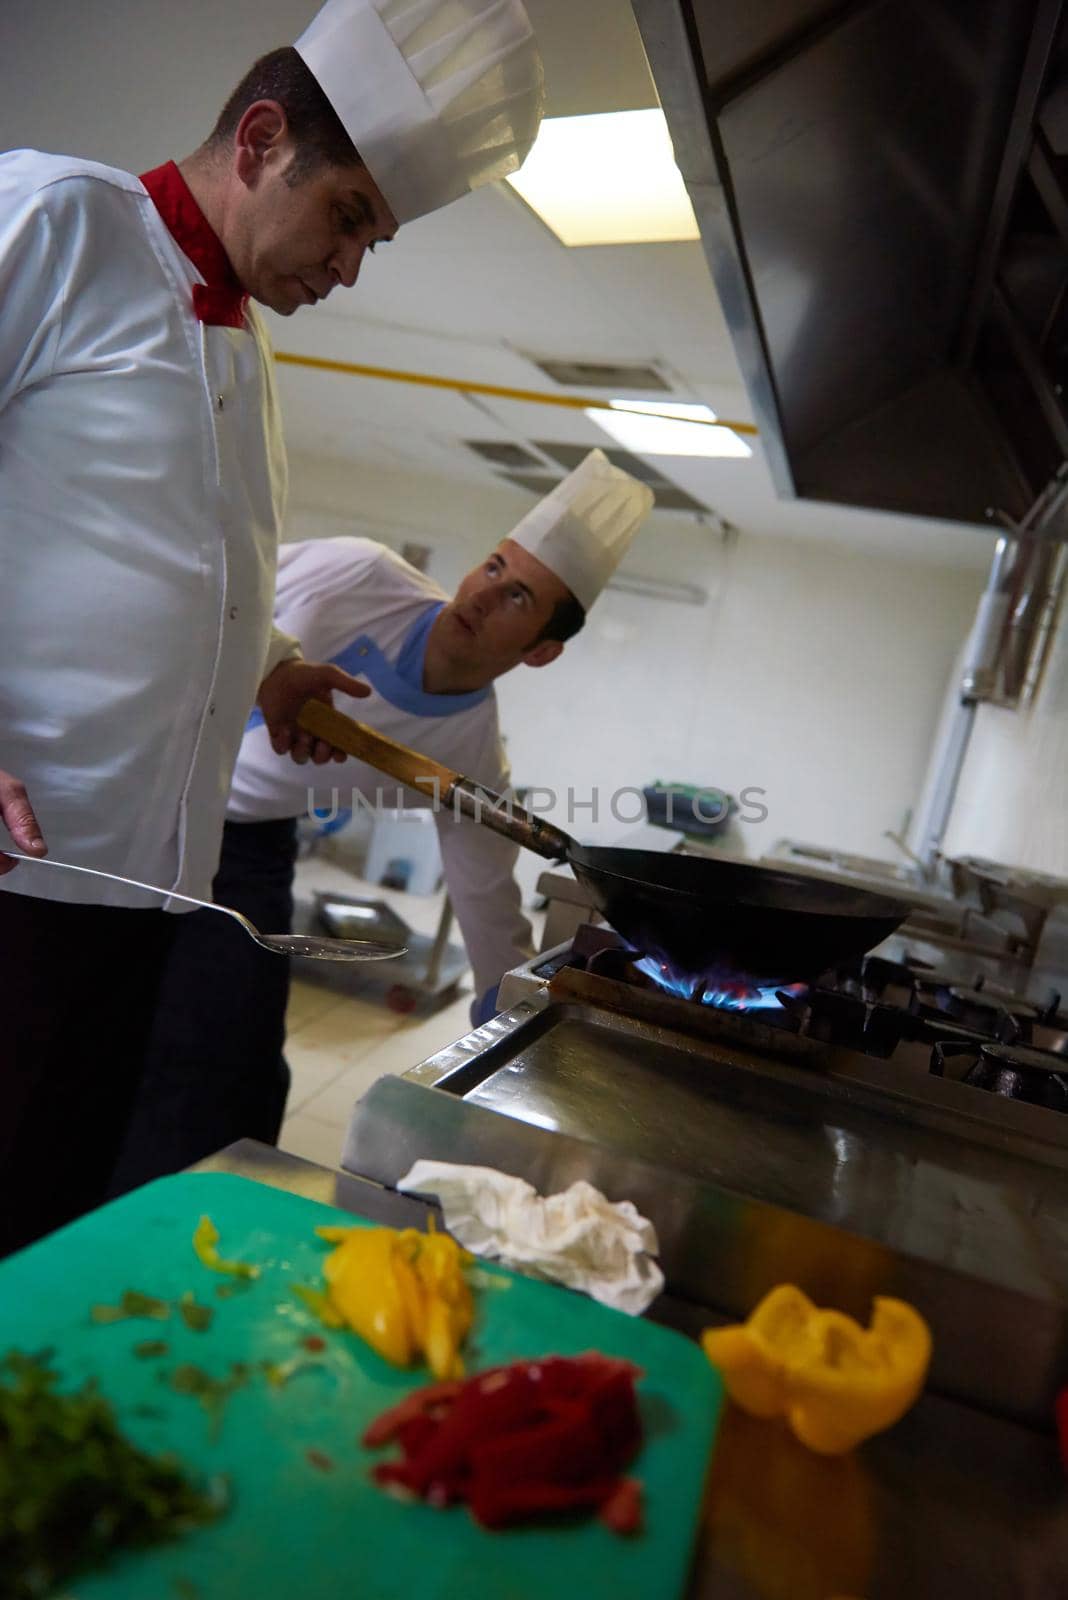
0;1350;227;1600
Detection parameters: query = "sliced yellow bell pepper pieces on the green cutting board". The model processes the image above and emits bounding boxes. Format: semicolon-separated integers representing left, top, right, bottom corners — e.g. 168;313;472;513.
317;1227;475;1378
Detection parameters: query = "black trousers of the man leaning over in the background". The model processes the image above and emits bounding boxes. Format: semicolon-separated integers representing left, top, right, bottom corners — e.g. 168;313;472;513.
110;819;297;1194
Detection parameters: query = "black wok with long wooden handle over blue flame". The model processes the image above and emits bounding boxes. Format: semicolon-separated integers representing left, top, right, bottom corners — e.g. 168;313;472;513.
297;701;910;984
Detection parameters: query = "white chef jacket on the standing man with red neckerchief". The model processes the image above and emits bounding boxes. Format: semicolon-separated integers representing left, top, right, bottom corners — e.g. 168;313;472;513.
0;150;299;910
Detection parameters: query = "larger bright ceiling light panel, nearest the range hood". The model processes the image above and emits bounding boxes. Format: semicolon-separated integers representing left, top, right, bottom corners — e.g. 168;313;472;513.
508;109;700;245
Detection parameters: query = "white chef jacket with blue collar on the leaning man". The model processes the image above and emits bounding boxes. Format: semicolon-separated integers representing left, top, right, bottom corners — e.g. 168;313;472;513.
227;539;532;995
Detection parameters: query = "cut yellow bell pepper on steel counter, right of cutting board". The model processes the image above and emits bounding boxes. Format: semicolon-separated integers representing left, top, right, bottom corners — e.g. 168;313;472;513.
702;1283;931;1456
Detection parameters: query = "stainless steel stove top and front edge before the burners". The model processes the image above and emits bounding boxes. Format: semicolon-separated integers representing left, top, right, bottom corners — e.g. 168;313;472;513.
342;921;1068;1419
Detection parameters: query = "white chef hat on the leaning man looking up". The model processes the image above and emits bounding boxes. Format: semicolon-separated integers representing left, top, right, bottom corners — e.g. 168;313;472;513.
508;450;656;611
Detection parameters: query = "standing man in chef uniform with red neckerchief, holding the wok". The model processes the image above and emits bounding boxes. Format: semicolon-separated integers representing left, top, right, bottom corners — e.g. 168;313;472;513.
0;0;542;1253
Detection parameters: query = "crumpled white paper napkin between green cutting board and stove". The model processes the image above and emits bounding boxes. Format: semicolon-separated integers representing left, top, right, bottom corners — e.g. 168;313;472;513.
397;1162;664;1317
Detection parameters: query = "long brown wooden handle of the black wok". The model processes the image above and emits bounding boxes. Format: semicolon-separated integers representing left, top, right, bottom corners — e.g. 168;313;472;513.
297;701;574;861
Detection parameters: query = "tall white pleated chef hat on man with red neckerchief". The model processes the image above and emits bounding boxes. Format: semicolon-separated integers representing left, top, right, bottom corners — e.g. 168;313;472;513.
296;0;545;222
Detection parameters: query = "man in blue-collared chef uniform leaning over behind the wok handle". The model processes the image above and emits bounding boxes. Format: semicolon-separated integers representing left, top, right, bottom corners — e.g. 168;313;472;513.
115;450;652;1189
